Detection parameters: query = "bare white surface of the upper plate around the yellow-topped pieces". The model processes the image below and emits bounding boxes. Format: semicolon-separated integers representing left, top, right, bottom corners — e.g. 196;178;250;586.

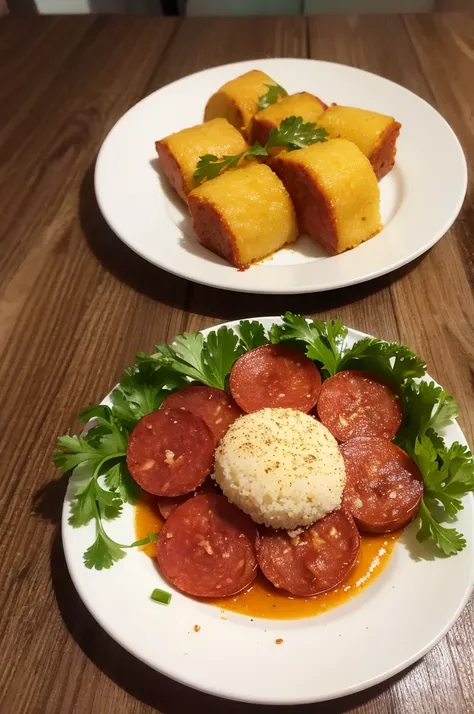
95;59;467;293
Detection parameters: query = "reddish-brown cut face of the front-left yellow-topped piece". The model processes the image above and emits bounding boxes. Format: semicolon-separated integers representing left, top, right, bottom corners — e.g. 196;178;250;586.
188;194;250;270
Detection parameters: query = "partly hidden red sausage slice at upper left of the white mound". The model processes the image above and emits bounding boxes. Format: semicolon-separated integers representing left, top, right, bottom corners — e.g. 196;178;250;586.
162;386;242;440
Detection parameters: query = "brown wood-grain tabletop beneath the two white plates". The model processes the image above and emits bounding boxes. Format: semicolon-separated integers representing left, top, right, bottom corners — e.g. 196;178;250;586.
0;13;474;714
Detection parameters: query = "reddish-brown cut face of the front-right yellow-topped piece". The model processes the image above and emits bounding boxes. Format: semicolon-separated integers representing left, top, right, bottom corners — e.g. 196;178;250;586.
270;155;338;255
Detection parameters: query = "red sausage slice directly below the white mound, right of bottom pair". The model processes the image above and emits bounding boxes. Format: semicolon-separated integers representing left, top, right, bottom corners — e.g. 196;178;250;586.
257;509;360;597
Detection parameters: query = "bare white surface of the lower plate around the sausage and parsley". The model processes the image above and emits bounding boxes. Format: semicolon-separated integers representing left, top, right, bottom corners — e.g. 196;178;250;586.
62;318;474;704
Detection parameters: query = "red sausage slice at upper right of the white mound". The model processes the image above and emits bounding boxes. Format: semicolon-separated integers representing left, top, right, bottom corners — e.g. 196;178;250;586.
318;369;402;441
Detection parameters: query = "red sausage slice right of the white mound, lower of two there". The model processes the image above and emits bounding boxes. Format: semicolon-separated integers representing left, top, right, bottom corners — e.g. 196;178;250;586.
341;437;423;533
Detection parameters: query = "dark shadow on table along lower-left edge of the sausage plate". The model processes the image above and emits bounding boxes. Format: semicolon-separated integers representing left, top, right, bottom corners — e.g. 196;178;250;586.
43;516;414;714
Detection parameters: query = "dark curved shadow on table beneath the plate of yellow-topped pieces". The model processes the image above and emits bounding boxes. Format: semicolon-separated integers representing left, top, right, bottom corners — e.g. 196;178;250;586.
79;164;423;320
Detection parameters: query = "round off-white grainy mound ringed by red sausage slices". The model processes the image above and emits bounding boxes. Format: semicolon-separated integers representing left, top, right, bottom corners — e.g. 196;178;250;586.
214;409;346;530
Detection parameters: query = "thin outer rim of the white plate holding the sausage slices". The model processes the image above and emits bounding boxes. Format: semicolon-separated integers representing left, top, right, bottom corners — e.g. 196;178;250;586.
61;316;474;706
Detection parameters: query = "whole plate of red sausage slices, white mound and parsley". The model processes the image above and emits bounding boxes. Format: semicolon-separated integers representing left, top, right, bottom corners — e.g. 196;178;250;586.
54;313;474;704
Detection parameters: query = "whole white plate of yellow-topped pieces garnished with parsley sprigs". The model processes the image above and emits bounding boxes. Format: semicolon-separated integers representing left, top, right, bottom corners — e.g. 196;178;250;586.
95;59;467;293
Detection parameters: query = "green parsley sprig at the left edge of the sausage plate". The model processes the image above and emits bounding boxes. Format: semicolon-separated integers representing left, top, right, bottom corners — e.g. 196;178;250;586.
53;363;178;570
